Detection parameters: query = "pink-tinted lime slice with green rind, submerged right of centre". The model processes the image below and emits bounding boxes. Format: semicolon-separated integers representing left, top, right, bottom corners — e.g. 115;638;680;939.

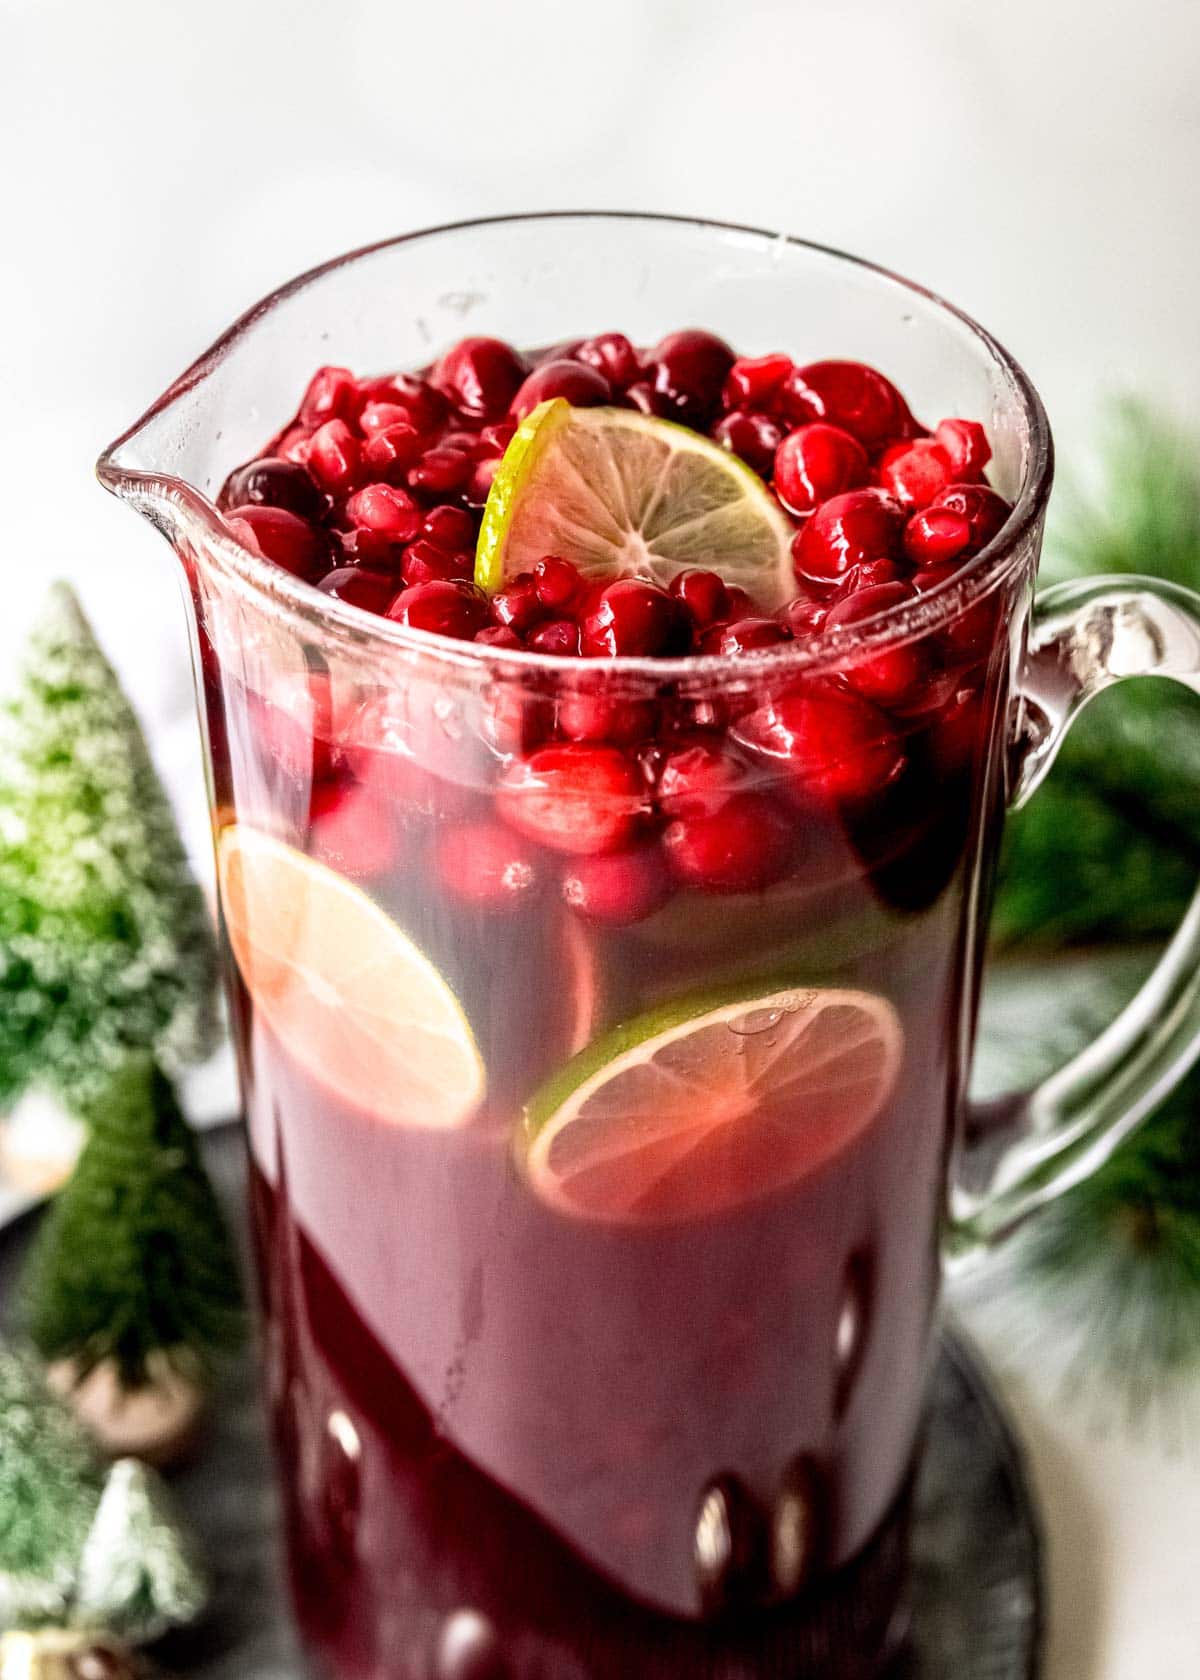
523;986;904;1225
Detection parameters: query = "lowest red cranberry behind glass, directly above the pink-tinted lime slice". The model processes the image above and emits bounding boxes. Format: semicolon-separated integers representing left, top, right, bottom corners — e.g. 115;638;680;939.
662;793;795;892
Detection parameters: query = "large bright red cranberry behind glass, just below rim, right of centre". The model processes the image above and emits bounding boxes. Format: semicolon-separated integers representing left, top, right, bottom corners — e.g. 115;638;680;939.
738;684;904;803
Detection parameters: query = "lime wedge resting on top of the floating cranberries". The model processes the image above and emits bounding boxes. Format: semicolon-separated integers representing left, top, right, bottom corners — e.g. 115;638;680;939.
476;396;795;612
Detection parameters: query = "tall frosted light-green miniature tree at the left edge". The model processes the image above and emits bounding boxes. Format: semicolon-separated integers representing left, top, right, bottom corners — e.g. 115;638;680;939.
0;583;217;1114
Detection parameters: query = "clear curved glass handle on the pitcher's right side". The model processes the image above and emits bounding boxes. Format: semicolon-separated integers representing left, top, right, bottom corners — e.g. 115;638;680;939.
948;576;1200;1263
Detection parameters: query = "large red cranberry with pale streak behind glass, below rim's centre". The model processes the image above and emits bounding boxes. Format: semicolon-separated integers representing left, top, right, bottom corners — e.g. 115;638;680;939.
496;741;644;857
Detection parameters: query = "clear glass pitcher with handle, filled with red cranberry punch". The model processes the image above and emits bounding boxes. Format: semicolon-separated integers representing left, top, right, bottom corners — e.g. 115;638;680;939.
99;213;1200;1680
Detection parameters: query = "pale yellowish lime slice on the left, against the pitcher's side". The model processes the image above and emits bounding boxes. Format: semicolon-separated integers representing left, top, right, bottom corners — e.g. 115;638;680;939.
217;823;486;1129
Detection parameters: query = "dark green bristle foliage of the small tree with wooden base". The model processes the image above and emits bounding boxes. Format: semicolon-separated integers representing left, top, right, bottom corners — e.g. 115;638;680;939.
25;1053;242;1389
